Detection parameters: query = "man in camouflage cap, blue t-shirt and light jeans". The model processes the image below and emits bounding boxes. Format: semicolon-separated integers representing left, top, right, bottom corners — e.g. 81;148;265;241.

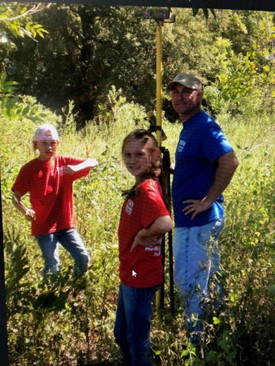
167;73;239;343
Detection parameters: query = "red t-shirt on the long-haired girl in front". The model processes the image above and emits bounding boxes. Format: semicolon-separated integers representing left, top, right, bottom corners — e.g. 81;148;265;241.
118;179;169;288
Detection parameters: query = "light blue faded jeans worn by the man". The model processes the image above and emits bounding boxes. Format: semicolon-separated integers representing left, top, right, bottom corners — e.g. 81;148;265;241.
173;219;224;334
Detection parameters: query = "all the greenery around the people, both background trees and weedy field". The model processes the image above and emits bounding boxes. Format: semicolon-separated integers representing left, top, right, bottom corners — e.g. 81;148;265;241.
0;3;275;366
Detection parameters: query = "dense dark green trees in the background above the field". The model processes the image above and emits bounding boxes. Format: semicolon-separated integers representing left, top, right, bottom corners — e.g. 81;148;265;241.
0;4;274;126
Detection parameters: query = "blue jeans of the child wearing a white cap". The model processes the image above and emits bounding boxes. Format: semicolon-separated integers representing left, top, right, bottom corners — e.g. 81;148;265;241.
36;228;89;279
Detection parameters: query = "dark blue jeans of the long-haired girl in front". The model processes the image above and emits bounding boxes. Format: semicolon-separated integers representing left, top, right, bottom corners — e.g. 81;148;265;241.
114;284;159;366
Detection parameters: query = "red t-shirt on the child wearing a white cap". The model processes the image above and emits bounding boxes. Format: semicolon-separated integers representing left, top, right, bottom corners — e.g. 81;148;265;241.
12;156;90;236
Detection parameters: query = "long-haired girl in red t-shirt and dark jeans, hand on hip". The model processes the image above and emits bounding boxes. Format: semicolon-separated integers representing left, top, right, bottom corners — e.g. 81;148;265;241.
114;129;172;366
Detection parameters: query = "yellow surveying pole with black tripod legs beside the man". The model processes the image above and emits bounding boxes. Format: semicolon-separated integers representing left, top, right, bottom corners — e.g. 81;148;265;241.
144;8;175;314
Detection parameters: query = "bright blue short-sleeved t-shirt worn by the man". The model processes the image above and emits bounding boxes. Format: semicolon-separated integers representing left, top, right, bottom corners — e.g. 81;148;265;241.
172;111;233;227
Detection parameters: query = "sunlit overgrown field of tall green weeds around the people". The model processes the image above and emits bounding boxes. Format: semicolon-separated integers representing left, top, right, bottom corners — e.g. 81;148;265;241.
0;103;275;366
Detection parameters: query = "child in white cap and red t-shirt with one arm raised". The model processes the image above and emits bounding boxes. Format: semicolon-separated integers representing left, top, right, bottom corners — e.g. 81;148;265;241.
12;124;98;279
